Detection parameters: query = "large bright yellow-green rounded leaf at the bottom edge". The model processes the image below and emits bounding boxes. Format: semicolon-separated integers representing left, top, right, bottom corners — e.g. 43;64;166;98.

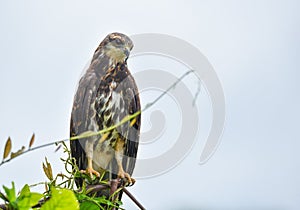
41;187;79;210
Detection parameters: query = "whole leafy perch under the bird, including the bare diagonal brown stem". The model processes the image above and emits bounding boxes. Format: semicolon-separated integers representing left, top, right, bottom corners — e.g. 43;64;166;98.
0;140;144;210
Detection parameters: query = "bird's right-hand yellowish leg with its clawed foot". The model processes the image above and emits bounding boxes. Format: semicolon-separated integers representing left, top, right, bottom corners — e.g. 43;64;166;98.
115;139;135;185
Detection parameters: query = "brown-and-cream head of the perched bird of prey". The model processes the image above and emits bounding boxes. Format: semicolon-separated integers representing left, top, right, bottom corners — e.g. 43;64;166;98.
100;32;133;63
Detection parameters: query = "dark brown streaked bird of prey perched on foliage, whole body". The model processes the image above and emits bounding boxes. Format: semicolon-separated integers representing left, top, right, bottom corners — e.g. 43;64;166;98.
70;33;140;186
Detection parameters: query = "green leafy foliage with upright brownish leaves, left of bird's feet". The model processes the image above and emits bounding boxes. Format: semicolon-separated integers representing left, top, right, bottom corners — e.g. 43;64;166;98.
0;141;122;210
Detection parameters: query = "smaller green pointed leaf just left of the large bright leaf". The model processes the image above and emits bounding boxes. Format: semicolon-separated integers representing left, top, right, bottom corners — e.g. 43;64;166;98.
17;184;43;210
